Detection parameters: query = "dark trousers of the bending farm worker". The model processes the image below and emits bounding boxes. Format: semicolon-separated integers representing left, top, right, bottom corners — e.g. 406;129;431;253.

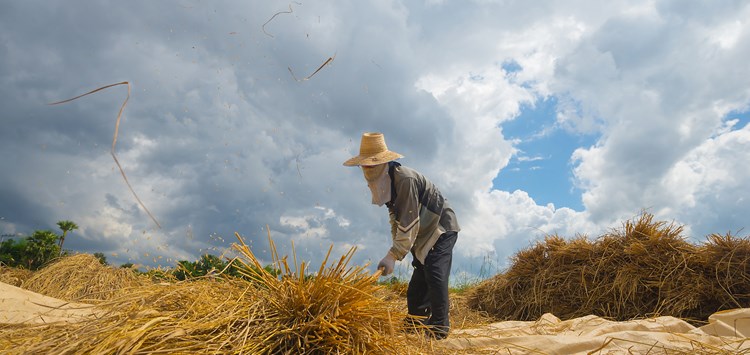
406;232;458;338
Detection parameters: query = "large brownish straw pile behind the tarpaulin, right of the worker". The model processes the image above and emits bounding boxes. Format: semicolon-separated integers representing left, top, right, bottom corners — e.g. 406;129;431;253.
468;212;750;324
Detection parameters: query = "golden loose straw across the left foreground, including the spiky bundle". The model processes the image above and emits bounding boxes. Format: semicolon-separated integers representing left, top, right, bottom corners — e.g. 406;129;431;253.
0;235;426;354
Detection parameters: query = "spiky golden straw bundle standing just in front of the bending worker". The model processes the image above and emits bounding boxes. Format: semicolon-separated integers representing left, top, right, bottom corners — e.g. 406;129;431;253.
229;231;418;354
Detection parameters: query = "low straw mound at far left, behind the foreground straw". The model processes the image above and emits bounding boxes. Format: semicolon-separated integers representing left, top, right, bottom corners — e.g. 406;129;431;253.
23;254;151;302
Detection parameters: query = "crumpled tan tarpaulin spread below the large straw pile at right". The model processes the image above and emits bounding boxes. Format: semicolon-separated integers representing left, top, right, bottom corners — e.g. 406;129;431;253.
440;308;750;354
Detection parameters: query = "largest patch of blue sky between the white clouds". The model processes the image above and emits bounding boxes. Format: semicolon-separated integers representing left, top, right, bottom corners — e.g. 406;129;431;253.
493;97;597;211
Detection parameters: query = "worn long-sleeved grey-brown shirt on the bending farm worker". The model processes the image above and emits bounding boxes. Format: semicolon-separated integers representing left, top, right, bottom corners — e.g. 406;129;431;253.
386;162;460;264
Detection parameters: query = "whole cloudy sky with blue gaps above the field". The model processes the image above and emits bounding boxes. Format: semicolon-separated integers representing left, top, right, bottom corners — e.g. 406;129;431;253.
0;0;750;280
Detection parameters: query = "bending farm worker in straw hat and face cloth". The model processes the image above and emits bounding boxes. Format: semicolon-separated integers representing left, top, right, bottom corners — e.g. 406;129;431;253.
344;133;460;339
